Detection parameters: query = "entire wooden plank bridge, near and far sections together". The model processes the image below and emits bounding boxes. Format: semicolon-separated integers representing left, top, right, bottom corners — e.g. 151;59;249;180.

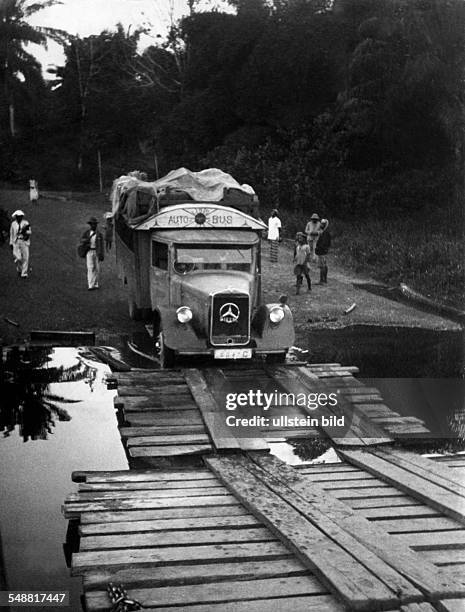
64;364;465;612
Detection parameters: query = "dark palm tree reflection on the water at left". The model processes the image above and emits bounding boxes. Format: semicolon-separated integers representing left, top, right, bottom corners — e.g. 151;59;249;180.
0;346;97;442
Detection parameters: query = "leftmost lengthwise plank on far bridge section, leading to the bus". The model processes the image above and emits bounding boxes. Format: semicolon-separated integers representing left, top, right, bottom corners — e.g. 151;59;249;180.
183;368;241;450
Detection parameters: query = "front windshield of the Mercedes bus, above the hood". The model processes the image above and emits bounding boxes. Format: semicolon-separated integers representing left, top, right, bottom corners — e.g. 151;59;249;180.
174;246;252;274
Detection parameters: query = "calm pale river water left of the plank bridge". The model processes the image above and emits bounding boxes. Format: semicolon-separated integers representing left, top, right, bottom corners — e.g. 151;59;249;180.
0;348;127;611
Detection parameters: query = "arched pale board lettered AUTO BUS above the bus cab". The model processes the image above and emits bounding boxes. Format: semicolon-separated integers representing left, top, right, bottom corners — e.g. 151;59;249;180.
134;202;266;231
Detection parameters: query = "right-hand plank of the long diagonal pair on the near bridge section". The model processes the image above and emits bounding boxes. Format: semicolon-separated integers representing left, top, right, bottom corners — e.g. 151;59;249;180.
246;455;465;602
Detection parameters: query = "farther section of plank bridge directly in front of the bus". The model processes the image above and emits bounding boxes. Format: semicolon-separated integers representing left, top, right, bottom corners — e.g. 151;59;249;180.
110;363;430;458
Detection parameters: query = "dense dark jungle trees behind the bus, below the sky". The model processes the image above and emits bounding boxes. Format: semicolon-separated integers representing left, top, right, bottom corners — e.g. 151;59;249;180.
0;0;465;305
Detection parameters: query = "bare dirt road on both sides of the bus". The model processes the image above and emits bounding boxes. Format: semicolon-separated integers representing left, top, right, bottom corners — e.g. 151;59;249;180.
0;191;459;344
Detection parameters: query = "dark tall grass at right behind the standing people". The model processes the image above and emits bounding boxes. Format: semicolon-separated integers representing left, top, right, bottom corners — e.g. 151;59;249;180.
264;211;465;309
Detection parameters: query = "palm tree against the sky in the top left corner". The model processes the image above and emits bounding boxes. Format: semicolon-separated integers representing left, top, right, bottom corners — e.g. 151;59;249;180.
0;0;67;138
